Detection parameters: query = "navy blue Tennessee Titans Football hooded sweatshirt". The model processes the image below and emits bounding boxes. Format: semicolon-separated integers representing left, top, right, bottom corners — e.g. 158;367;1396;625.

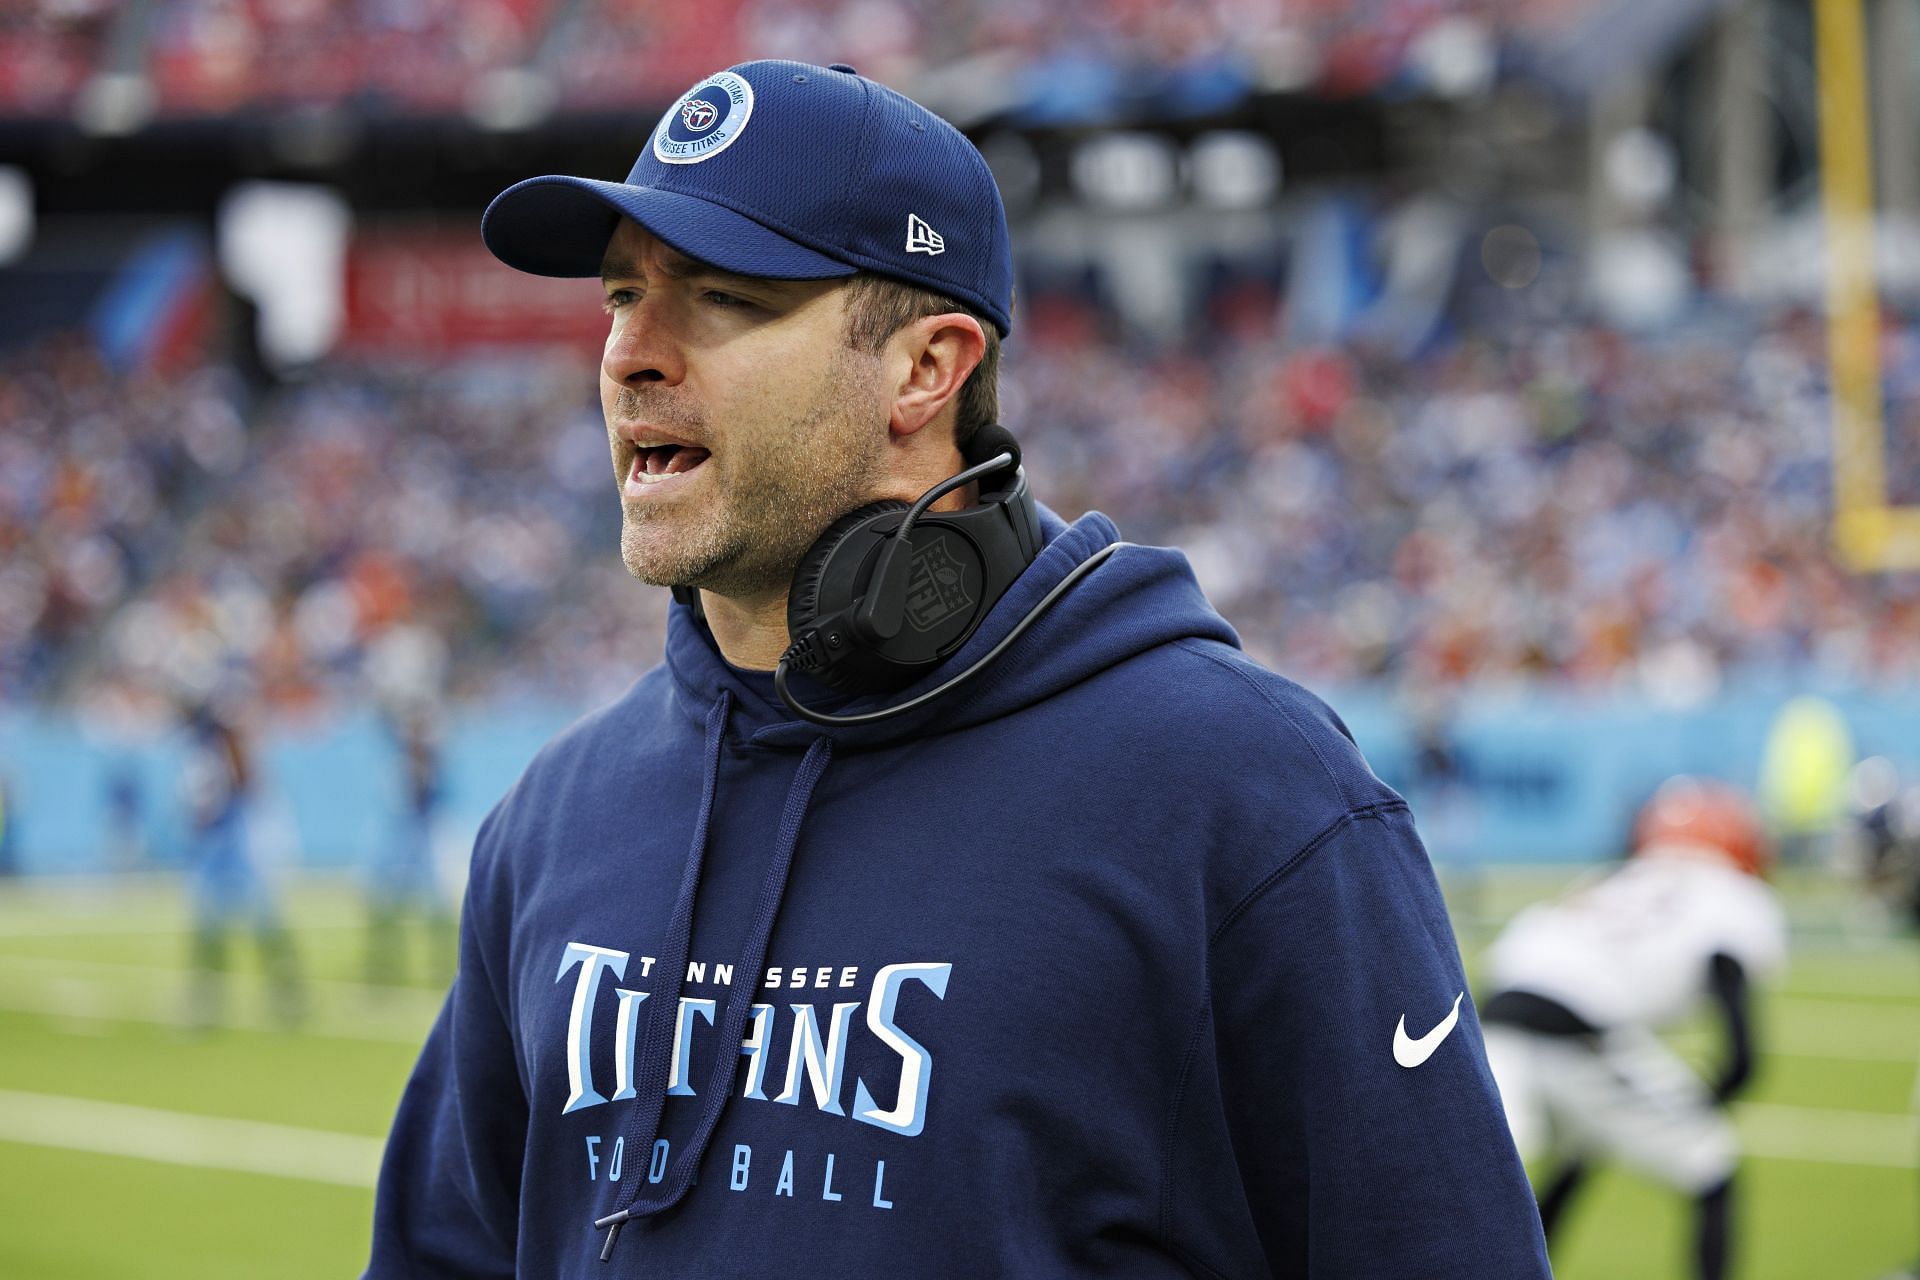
367;514;1549;1280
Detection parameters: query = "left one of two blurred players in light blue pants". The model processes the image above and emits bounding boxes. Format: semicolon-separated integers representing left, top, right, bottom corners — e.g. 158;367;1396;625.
180;702;303;1031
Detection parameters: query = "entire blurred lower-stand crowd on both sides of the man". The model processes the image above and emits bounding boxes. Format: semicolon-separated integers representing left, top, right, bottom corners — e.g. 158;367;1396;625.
0;297;1920;714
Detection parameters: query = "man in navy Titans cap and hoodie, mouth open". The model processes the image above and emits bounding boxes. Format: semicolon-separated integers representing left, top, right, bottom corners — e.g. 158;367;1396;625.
369;61;1548;1280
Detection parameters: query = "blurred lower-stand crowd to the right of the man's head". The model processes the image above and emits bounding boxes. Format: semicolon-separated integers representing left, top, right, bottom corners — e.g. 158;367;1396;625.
1014;297;1920;702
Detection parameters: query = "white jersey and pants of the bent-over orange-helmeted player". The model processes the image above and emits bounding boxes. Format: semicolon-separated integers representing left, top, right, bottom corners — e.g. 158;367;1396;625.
1484;854;1786;1192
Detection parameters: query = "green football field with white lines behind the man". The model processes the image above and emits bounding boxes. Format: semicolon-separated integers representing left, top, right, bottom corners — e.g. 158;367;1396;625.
0;873;1920;1280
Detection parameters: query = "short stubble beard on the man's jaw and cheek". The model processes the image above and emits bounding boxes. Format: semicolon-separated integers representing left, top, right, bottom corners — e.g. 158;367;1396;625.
620;353;885;597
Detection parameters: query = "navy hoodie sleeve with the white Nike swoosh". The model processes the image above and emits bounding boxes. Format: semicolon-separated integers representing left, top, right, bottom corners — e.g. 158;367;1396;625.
1210;800;1551;1280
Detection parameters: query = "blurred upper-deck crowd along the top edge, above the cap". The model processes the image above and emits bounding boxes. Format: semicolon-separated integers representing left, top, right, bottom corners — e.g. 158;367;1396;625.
0;0;1596;115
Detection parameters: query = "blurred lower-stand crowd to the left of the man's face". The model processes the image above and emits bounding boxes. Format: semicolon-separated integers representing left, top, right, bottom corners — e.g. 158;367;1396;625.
0;351;664;714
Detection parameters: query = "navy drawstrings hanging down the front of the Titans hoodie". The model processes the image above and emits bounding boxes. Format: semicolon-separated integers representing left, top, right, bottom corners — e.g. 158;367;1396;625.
593;691;833;1263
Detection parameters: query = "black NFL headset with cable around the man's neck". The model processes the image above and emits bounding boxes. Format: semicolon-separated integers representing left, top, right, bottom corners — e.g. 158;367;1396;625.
674;424;1125;725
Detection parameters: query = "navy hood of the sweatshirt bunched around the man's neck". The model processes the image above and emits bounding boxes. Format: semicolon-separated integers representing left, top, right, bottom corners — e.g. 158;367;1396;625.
666;507;1240;752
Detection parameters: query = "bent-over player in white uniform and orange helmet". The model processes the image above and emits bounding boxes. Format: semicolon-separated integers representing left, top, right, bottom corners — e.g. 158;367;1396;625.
1482;777;1786;1280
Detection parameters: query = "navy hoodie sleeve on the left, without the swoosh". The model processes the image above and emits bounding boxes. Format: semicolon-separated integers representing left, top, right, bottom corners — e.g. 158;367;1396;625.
365;819;528;1280
